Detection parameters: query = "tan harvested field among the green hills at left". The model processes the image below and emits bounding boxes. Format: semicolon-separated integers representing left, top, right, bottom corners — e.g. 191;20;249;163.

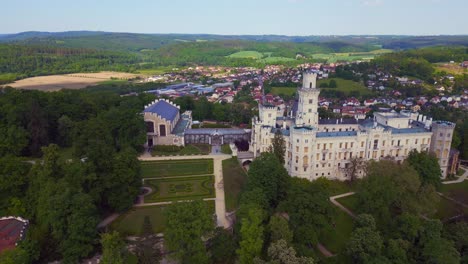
5;72;138;91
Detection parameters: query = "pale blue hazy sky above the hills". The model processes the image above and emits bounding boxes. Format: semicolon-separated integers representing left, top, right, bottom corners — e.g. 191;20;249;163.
0;0;468;36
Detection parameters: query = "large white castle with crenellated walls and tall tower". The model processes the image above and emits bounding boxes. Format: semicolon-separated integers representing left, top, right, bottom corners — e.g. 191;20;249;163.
250;73;455;180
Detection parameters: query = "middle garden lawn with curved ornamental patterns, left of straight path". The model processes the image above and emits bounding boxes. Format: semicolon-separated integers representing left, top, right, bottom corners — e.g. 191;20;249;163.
144;175;214;203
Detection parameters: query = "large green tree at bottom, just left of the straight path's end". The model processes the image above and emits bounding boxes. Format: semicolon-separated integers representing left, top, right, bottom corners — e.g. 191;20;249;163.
164;201;214;263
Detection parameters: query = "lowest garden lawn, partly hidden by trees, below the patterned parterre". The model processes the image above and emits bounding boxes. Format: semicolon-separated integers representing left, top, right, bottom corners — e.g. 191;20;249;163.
110;201;215;236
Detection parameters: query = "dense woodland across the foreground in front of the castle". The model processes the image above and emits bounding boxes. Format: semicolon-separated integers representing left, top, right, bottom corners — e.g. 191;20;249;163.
156;150;468;264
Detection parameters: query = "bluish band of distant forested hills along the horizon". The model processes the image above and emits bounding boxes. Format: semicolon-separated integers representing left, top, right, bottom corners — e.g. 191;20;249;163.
0;31;468;52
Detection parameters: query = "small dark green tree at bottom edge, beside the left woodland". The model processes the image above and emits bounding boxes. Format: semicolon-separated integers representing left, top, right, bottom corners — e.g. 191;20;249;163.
101;231;125;264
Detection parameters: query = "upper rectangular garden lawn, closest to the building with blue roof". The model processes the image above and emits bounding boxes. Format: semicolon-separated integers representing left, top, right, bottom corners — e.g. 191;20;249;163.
141;159;213;178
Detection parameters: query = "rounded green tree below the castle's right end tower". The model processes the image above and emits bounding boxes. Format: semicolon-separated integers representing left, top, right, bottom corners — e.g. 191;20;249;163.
406;150;441;188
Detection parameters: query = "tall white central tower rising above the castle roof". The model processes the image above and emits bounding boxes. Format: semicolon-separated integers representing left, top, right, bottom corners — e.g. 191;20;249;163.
296;72;320;126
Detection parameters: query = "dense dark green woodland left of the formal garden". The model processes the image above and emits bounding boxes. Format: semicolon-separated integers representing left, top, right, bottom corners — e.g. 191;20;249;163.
0;86;153;263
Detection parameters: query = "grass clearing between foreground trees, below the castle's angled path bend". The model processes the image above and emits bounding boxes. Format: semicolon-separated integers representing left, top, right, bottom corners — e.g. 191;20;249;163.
319;207;354;254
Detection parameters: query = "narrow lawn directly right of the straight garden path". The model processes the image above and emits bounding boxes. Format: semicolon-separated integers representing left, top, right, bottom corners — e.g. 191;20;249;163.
223;158;247;211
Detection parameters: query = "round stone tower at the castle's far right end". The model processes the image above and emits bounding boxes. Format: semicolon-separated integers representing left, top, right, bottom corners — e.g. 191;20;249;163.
430;121;455;179
